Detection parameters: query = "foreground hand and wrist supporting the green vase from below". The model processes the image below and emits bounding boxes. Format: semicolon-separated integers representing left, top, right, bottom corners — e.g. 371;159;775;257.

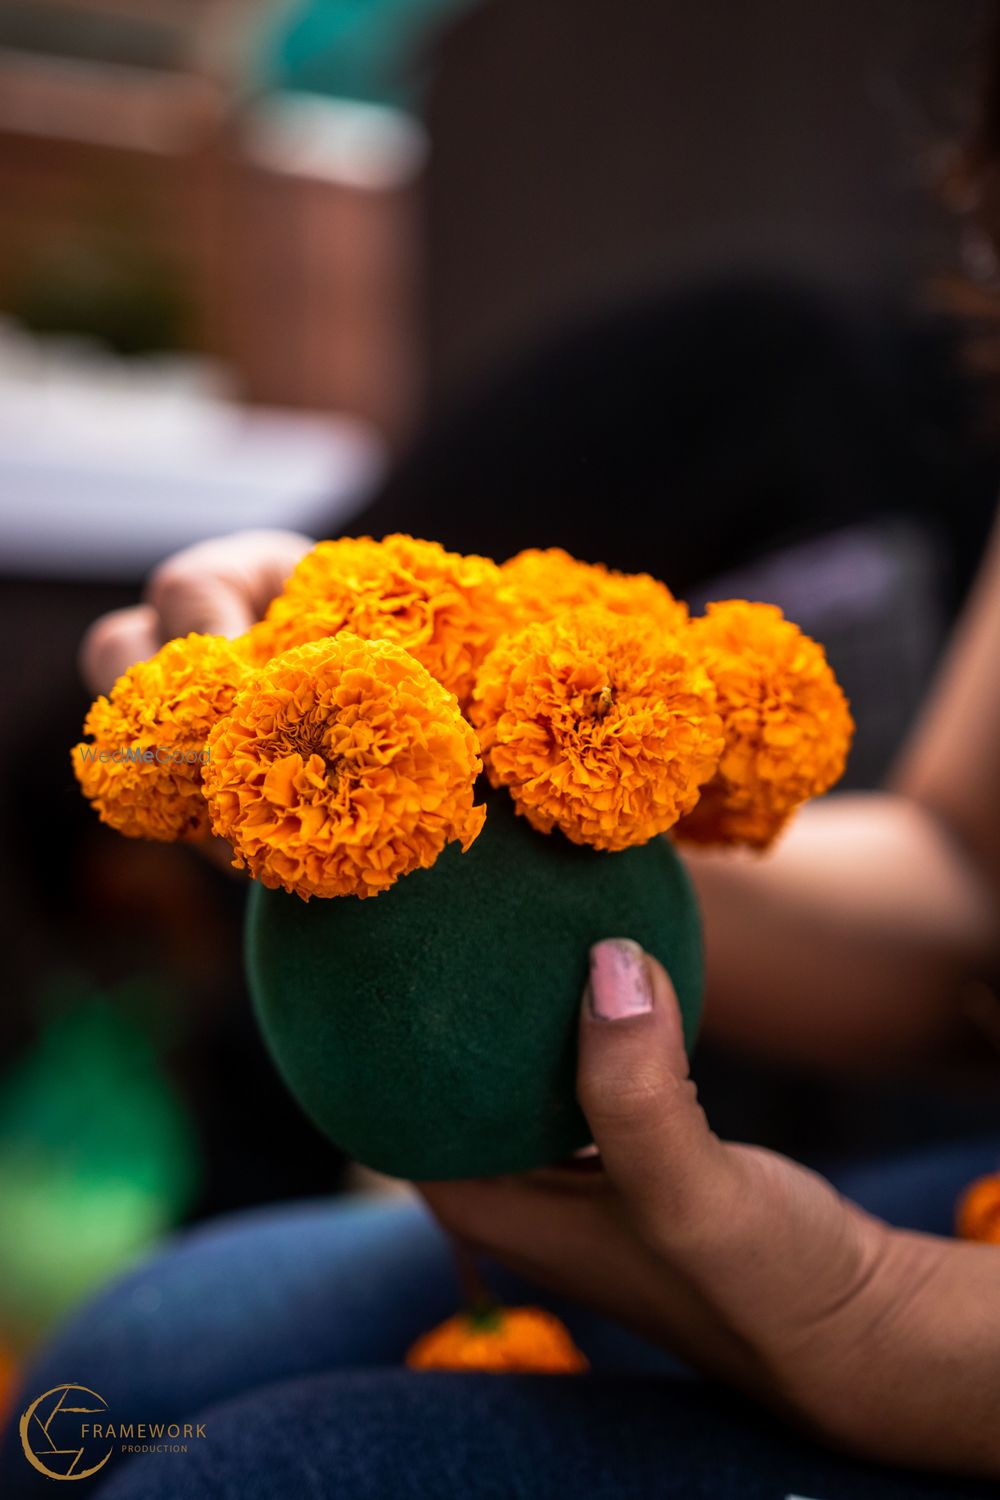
420;939;1000;1478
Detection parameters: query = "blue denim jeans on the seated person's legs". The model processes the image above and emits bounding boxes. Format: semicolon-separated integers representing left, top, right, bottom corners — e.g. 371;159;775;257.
0;1142;1000;1500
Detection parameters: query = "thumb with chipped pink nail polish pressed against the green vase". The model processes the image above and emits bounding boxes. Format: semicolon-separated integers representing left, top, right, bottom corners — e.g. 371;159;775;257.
577;938;733;1247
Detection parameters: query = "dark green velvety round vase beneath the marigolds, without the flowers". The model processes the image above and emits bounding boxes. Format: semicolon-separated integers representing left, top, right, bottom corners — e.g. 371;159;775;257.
247;794;702;1181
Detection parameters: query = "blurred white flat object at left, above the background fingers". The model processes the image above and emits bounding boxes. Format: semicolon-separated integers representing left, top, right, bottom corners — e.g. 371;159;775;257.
0;326;385;581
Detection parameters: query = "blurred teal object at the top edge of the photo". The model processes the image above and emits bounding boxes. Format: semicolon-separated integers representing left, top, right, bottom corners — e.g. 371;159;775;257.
255;0;478;108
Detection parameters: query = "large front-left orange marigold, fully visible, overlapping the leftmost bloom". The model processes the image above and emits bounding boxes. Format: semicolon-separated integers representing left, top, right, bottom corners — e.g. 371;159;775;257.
205;633;486;900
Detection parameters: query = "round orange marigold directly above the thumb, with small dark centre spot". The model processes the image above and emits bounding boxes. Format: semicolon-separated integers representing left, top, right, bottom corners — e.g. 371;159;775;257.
471;609;723;849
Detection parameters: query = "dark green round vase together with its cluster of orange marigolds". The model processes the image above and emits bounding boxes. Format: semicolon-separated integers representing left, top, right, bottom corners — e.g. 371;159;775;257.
75;536;853;1182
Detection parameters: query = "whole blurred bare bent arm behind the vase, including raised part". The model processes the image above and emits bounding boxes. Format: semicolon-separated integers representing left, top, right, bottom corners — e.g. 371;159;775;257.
690;510;1000;1064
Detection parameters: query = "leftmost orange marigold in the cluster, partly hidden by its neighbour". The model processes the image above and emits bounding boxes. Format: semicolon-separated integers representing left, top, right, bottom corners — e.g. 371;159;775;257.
72;635;250;843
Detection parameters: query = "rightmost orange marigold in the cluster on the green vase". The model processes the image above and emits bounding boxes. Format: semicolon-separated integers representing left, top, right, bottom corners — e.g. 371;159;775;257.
678;599;855;849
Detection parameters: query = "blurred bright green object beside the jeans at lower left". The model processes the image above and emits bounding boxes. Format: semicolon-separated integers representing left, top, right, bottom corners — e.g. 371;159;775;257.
0;992;198;1349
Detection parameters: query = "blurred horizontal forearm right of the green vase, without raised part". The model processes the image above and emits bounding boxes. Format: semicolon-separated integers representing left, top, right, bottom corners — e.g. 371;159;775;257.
688;794;997;1067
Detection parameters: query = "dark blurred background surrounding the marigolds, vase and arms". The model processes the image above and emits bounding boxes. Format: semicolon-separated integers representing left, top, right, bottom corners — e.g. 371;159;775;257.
0;0;997;1404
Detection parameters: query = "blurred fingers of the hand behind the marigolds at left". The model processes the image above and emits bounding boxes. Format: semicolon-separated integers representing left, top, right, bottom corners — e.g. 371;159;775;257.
79;531;313;693
